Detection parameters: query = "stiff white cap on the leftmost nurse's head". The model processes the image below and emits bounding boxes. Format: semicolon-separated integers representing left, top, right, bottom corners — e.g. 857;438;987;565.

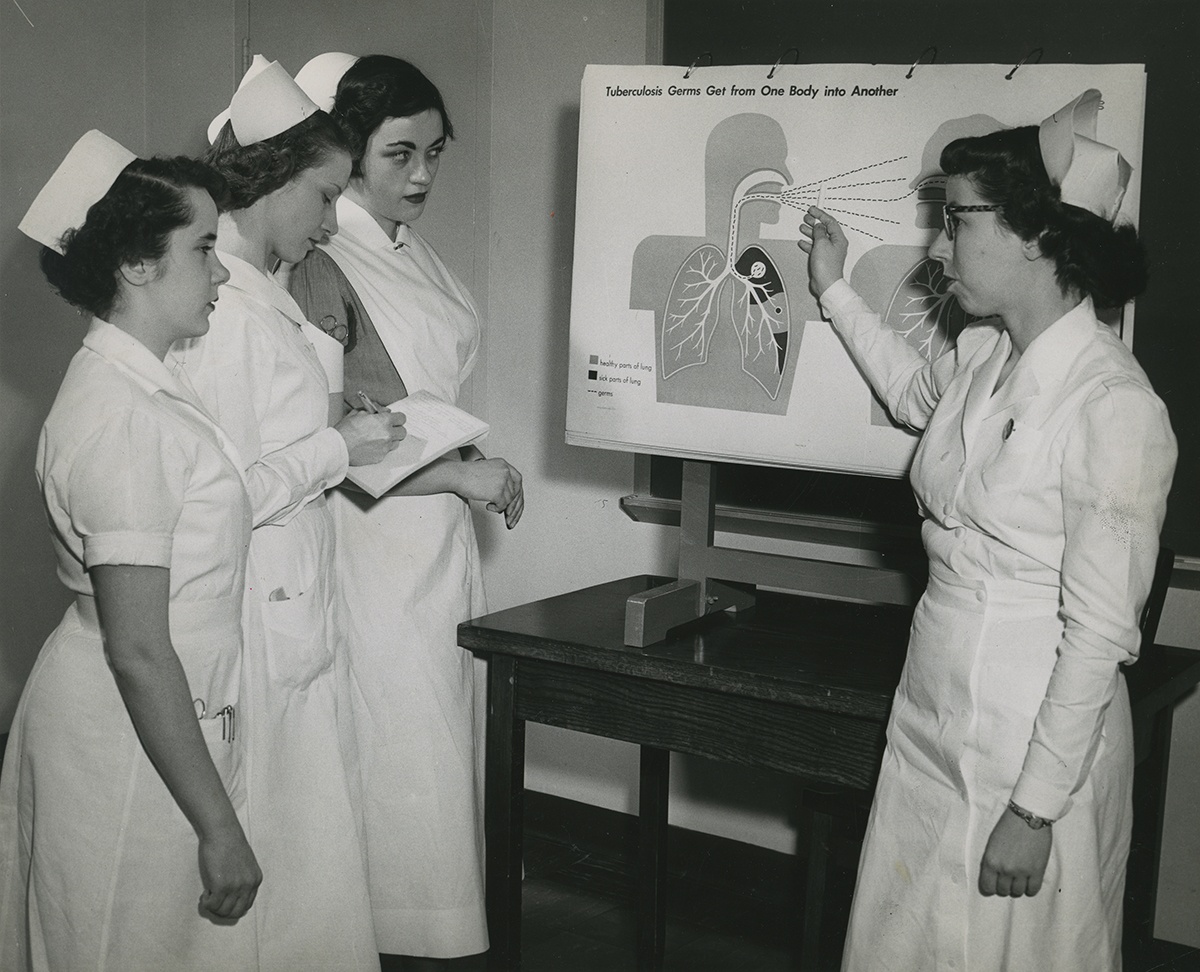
17;128;137;253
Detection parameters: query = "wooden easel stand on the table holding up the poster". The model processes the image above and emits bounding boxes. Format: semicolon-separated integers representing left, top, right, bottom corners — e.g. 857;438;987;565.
625;460;913;648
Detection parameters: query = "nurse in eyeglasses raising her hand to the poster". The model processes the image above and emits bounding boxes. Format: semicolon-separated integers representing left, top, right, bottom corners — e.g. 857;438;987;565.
800;90;1176;972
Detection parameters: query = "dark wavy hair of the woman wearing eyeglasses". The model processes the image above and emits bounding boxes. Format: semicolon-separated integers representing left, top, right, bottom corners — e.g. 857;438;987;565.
941;125;1147;308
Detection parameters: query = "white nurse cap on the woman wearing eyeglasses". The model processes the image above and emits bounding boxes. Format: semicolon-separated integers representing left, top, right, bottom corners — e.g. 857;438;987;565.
1038;88;1133;222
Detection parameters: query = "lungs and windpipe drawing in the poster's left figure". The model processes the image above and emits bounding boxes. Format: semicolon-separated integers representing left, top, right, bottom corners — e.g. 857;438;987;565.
661;169;800;400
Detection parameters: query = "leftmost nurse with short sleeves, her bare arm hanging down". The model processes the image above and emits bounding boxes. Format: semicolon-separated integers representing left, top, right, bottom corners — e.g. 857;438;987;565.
0;131;262;972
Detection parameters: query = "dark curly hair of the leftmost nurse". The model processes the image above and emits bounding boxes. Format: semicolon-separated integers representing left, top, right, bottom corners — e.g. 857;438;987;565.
41;156;224;318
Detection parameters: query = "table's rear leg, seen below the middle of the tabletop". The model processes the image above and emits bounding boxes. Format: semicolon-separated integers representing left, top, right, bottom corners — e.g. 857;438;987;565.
637;746;671;972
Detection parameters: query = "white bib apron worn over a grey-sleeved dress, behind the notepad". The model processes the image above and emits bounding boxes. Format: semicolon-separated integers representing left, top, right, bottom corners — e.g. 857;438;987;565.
293;196;487;958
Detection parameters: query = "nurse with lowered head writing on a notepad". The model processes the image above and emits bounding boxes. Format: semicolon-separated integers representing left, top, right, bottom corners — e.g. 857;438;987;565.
179;58;403;972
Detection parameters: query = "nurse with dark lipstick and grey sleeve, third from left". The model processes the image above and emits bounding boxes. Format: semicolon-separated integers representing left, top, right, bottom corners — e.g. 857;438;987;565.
290;55;524;967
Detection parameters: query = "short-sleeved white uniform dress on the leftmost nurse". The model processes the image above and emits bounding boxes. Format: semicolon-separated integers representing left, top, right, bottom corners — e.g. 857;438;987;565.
0;320;257;972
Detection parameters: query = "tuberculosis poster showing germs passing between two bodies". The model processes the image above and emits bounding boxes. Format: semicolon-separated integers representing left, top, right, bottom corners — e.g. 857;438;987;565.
566;65;1146;476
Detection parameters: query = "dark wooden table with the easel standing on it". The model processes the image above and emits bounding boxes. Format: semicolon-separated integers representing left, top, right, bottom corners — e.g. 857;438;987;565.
458;575;1200;970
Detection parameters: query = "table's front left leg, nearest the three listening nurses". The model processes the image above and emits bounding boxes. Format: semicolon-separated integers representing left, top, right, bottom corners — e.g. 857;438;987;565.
484;655;524;972
